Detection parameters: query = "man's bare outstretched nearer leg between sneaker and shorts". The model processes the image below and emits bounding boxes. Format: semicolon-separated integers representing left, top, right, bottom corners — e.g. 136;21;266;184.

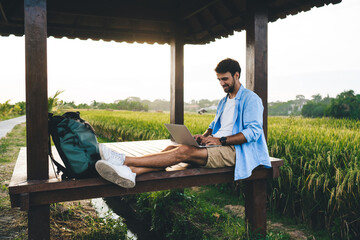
124;145;208;169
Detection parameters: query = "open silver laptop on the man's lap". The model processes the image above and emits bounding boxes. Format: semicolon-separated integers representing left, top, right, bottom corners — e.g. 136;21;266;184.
165;124;221;148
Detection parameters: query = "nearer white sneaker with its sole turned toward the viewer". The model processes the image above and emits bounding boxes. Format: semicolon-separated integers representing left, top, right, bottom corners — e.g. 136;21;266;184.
95;160;136;188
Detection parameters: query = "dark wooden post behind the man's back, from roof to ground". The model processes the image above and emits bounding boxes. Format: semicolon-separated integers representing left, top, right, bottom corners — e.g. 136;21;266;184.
245;0;268;238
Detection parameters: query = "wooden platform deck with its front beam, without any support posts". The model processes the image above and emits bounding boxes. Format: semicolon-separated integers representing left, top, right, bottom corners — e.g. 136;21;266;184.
9;140;283;210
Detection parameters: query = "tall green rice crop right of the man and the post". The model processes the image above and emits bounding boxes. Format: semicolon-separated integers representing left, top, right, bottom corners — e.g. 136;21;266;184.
268;118;360;239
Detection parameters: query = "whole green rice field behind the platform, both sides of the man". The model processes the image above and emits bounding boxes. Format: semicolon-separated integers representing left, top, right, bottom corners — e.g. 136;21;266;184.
81;111;360;239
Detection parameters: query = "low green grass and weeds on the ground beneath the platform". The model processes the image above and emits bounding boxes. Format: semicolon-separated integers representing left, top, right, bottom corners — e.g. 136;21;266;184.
119;186;291;240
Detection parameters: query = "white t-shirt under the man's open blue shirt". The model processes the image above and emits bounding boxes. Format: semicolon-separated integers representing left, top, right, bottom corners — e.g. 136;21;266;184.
214;97;235;138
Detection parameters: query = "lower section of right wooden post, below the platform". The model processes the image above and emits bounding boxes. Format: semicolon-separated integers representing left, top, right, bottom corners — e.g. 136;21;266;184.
245;179;267;239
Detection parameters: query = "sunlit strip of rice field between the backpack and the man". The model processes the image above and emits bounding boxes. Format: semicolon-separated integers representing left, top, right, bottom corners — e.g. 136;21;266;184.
81;110;214;142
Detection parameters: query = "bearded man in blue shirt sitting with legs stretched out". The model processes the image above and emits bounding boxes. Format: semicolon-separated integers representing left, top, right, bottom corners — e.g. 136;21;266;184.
96;58;271;188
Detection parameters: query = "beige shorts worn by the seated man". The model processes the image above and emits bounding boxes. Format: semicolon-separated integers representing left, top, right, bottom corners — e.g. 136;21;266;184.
205;145;236;168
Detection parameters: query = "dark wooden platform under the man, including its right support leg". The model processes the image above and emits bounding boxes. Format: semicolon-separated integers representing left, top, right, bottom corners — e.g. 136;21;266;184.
9;140;283;237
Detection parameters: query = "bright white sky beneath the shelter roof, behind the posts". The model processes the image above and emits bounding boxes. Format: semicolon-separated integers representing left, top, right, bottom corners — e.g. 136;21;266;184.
0;0;360;104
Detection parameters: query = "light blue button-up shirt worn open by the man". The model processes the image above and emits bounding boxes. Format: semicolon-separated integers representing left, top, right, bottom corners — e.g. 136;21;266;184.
209;85;271;180
